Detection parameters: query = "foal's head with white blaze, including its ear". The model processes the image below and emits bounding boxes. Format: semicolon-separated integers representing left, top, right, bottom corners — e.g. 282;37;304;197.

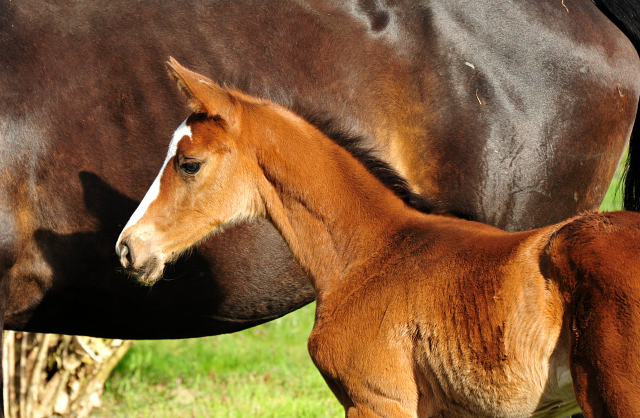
116;59;264;285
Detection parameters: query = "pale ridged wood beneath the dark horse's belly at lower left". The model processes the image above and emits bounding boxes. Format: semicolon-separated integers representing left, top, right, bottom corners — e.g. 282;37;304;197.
2;331;133;418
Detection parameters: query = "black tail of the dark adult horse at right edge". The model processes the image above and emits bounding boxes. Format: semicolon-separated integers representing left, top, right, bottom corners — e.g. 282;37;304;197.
593;0;640;212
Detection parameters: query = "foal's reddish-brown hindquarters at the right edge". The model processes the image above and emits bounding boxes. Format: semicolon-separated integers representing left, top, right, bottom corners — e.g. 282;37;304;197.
542;212;640;417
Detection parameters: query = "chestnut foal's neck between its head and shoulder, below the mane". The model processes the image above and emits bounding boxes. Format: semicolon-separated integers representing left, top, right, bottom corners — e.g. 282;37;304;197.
252;109;417;302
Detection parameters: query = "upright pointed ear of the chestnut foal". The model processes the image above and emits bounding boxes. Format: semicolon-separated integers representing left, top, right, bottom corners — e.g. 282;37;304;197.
167;57;238;128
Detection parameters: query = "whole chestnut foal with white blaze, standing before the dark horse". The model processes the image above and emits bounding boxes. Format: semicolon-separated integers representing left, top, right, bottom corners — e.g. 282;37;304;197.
116;60;640;418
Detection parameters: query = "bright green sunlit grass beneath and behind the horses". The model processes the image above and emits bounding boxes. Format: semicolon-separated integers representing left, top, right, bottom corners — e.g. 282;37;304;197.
91;159;621;418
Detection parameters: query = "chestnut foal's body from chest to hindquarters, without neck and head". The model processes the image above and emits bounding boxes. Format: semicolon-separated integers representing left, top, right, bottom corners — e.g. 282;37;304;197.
309;213;640;417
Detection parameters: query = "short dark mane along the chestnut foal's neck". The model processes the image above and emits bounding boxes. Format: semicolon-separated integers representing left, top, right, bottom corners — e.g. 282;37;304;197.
293;109;442;213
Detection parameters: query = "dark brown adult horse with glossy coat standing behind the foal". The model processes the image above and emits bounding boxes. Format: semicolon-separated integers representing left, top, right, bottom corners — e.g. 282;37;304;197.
0;0;640;350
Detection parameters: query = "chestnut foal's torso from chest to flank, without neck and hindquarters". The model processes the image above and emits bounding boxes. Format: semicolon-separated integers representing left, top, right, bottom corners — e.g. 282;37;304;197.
309;219;578;417
